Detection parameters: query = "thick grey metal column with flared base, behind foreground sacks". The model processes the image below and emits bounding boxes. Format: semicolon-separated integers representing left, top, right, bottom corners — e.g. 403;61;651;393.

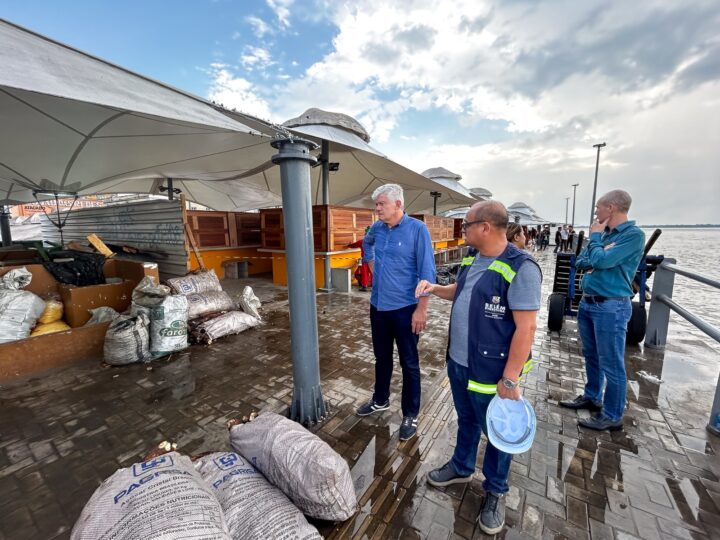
271;138;327;425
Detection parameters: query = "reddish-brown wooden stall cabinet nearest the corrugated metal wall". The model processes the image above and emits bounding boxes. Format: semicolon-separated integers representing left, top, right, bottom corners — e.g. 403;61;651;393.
187;210;260;248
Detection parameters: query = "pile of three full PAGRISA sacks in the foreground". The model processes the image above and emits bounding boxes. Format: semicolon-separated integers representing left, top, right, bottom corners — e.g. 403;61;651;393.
70;413;357;540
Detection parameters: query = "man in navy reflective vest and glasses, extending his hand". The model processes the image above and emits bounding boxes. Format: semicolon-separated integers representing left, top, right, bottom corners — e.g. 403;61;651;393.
416;201;542;534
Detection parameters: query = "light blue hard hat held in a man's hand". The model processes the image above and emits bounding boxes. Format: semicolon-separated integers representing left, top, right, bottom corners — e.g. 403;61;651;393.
487;395;537;454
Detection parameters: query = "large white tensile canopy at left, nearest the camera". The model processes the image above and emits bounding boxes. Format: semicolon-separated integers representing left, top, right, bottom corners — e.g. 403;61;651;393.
0;16;280;208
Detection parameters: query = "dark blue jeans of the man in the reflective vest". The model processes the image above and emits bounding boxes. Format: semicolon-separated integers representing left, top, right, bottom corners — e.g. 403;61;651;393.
448;360;512;493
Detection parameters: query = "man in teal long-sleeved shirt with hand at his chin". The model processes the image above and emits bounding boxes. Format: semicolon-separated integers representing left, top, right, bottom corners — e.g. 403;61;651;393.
560;189;645;431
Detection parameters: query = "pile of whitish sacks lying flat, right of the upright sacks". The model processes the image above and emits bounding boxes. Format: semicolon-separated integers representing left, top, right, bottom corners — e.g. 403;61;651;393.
168;270;260;343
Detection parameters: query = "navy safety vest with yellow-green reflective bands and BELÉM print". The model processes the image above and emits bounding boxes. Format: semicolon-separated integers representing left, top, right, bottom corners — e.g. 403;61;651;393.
448;242;539;394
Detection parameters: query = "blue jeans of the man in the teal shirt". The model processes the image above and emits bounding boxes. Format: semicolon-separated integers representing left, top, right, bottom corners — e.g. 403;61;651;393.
578;298;632;422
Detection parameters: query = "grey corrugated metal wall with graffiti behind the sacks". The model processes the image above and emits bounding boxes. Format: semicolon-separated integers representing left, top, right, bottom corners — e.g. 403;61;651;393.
42;200;188;280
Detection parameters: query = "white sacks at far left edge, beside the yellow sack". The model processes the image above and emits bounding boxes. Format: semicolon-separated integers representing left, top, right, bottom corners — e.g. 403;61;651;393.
0;267;46;343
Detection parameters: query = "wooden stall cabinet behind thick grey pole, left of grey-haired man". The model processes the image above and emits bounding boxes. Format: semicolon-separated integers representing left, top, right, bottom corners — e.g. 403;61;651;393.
260;205;375;251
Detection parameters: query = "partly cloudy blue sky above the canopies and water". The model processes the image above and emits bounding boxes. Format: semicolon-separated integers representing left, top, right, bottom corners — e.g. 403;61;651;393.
0;0;720;224
